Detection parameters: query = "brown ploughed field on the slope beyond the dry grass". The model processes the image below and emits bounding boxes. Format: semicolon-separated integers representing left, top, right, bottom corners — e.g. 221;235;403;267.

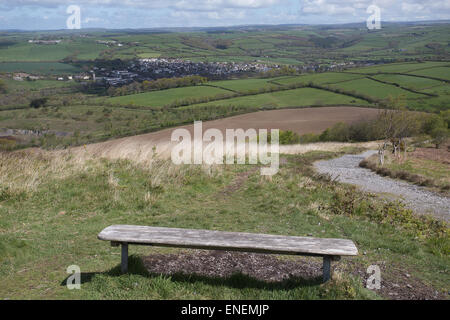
73;107;378;159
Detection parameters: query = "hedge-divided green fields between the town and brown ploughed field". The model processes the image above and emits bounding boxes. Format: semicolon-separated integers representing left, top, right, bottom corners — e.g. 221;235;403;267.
0;62;450;147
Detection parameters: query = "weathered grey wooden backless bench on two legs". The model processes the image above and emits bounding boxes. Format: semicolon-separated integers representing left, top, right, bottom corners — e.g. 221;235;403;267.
98;225;358;282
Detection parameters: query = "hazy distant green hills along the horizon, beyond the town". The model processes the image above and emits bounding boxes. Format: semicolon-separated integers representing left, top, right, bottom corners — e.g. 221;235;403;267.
0;23;450;65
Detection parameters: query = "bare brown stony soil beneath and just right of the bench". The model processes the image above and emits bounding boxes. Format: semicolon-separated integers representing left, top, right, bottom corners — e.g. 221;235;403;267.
143;250;447;300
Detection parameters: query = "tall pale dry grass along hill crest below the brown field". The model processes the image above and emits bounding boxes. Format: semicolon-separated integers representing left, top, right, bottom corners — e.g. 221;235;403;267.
0;149;222;202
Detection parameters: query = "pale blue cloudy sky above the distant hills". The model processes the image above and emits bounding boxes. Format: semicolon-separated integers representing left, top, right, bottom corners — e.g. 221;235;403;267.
0;0;450;30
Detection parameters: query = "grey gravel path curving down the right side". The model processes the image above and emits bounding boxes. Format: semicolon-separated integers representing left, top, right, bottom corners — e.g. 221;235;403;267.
314;150;450;222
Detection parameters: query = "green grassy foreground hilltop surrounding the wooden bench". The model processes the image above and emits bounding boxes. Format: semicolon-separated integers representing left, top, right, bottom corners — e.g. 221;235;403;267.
0;152;450;299
